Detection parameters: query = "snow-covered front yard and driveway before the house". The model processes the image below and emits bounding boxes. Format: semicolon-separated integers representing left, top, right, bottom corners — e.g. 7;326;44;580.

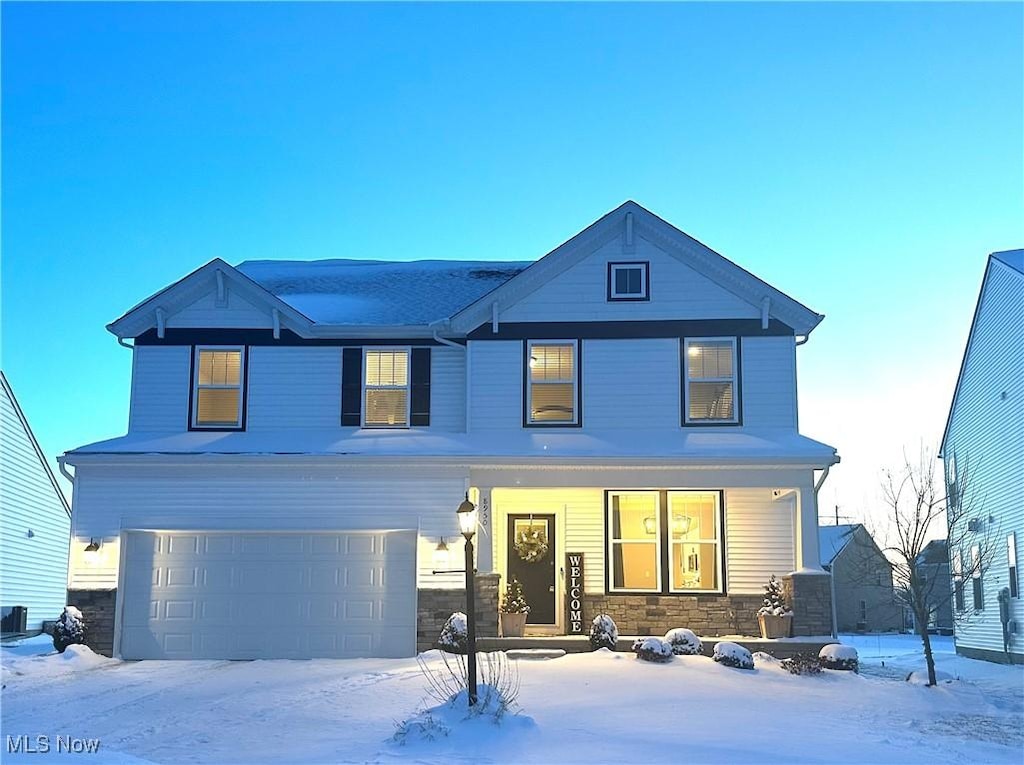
0;636;1024;764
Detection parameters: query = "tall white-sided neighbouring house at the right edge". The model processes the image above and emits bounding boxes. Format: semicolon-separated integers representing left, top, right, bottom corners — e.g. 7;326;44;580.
941;250;1024;662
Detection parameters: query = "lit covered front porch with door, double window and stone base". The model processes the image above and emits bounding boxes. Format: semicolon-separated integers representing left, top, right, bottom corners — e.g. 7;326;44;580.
470;466;831;638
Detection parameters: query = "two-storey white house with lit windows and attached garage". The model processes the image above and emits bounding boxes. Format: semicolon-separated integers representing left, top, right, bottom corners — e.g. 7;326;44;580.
63;202;839;657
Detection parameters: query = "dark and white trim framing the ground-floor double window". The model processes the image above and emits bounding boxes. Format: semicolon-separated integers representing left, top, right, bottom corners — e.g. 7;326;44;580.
604;486;729;598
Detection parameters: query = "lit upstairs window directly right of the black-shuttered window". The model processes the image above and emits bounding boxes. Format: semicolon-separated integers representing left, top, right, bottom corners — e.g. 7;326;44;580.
525;340;580;425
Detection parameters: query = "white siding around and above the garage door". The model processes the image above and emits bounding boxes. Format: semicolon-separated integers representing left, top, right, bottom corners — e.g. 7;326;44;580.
71;458;467;588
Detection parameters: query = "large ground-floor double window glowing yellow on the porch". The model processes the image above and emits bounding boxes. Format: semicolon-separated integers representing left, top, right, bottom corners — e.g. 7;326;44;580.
607;491;725;594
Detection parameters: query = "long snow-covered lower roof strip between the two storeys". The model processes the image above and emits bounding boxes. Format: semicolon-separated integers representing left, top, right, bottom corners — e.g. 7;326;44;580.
69;428;838;466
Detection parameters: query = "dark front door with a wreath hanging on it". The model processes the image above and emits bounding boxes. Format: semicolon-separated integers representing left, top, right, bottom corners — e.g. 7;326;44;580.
508;515;557;627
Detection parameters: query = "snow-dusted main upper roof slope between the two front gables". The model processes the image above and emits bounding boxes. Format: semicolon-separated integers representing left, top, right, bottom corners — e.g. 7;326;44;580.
237;259;529;326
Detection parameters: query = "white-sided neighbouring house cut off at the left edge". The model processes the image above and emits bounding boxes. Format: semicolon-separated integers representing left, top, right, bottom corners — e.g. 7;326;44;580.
0;372;71;632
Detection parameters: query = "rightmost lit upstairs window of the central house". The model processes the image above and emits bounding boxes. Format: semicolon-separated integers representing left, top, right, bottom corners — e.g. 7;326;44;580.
683;337;739;424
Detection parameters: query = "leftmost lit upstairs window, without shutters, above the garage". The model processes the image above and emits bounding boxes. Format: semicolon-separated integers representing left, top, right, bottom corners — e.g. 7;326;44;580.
191;347;245;429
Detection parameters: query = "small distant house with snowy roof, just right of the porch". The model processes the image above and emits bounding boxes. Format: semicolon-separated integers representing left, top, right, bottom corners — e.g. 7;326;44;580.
818;523;903;632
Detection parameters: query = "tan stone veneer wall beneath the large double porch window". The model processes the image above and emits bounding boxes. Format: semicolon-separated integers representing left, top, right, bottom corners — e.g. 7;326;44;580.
584;594;762;636
